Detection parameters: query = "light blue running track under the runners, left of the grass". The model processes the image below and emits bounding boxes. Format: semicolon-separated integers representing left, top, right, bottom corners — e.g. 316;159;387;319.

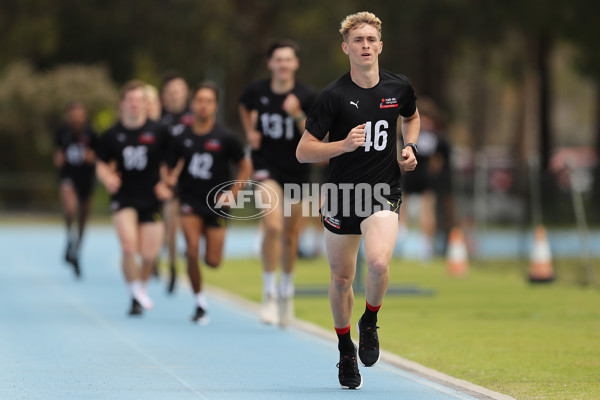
0;225;508;400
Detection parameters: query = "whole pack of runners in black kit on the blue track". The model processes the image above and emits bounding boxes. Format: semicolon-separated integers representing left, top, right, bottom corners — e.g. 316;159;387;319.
55;12;420;389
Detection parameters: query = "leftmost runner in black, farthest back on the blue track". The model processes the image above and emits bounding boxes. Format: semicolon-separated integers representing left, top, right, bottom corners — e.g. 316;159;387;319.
54;101;98;277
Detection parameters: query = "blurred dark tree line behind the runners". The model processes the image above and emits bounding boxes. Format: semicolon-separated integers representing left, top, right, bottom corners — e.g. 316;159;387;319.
0;0;600;225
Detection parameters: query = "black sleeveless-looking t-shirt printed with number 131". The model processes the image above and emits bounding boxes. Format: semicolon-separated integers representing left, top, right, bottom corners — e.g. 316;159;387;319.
240;79;317;181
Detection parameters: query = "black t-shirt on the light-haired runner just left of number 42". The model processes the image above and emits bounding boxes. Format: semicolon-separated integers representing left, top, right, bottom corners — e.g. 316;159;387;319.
97;120;169;205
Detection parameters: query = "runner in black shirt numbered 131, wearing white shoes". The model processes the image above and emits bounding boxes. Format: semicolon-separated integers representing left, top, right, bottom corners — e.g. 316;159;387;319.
239;40;316;326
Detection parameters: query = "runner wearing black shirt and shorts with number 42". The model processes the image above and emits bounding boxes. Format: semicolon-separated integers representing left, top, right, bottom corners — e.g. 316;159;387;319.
167;82;252;324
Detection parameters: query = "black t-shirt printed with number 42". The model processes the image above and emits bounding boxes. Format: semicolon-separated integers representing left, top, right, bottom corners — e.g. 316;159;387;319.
167;124;244;203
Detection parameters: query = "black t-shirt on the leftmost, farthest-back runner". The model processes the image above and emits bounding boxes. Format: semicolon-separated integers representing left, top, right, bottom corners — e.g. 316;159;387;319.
55;126;98;180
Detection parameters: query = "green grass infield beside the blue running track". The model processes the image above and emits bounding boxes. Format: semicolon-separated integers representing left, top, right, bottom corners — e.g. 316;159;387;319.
196;258;600;400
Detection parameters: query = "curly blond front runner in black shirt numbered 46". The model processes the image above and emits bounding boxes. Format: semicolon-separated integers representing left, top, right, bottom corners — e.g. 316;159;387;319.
296;12;419;389
